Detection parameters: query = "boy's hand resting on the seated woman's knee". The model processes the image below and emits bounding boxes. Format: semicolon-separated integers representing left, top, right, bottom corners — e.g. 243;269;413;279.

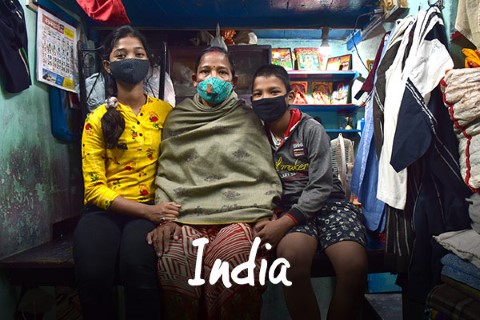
253;216;295;247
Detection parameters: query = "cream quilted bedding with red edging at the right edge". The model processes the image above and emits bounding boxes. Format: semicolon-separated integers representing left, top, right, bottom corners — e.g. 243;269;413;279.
441;68;480;191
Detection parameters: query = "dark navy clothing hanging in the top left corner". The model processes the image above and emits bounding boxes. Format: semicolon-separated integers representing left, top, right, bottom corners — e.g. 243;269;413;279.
0;0;32;93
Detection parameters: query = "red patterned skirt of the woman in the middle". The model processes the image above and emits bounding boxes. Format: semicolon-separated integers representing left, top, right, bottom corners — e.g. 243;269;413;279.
158;223;266;319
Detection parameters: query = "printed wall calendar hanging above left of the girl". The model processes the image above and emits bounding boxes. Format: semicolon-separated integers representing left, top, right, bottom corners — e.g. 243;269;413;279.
37;7;78;92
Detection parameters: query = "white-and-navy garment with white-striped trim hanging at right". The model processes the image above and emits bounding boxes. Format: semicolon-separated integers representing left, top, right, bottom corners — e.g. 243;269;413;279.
388;7;453;171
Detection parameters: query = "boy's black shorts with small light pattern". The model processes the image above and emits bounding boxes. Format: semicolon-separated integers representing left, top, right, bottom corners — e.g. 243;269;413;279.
289;199;366;251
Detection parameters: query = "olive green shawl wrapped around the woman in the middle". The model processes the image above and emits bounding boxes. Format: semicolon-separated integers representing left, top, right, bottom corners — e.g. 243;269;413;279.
155;93;281;225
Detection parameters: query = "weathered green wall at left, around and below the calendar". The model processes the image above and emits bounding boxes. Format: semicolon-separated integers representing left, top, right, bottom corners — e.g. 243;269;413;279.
0;6;83;319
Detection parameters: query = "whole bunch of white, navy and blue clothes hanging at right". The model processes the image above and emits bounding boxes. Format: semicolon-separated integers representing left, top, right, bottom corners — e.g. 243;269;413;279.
351;6;471;303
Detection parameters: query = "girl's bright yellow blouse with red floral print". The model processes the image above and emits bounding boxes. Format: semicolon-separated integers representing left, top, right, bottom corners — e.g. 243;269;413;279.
82;97;172;209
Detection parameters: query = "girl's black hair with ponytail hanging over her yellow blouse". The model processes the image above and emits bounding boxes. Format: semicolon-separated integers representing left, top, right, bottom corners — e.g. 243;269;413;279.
101;25;153;149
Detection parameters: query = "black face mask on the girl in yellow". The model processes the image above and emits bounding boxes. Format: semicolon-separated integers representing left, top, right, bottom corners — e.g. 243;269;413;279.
110;59;150;84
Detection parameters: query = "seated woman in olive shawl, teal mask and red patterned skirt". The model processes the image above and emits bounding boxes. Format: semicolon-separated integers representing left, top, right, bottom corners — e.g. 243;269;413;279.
147;48;281;319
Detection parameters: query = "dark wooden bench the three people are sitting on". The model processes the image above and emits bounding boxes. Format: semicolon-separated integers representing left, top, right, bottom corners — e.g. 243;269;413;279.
0;217;388;287
